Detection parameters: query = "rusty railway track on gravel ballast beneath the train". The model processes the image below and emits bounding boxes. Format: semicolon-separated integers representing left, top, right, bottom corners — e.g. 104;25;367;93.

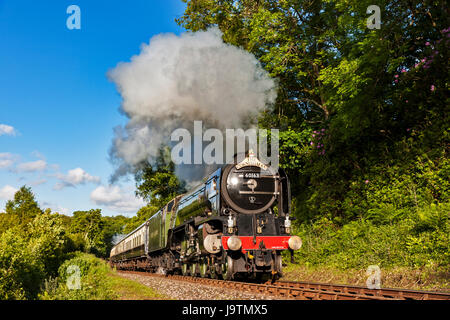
117;270;450;300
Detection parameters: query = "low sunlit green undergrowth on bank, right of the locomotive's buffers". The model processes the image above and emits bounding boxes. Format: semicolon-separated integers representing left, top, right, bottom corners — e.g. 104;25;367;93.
296;202;450;270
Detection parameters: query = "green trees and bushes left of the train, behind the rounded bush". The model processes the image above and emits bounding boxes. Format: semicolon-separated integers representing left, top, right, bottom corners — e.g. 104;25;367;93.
0;187;129;299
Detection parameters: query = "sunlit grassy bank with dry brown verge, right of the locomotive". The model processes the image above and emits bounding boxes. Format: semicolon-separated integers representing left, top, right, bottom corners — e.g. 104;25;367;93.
284;202;450;292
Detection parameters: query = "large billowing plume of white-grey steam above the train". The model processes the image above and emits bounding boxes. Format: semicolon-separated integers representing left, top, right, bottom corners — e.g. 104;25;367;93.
108;28;276;181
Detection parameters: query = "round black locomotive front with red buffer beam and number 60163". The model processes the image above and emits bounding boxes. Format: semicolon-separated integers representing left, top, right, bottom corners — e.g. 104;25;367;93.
214;152;301;278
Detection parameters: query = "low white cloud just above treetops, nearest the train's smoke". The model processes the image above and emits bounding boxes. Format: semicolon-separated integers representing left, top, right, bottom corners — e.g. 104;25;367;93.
91;185;145;213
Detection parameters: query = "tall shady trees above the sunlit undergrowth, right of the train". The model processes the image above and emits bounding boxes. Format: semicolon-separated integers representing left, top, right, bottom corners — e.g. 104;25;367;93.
177;0;450;223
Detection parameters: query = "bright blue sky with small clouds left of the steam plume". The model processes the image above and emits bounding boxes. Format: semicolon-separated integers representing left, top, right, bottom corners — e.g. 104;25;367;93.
0;0;185;216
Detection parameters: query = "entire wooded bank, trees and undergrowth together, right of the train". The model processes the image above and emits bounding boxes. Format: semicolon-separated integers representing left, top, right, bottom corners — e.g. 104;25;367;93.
181;0;450;268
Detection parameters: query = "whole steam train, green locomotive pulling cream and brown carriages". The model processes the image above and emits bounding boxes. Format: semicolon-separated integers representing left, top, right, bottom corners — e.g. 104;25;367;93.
110;151;302;280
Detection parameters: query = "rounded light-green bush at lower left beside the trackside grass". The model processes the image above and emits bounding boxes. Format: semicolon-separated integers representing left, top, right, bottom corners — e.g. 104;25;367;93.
39;253;117;300
